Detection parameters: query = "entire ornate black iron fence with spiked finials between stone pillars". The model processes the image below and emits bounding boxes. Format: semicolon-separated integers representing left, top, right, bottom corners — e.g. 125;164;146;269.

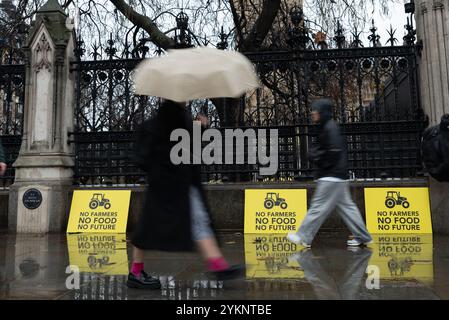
71;18;426;185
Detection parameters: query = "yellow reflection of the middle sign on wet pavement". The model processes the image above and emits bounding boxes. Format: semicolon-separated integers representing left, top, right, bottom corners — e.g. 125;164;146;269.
245;234;304;279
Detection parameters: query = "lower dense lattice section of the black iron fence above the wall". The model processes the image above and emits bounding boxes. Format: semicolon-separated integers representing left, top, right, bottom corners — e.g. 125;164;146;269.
68;121;426;185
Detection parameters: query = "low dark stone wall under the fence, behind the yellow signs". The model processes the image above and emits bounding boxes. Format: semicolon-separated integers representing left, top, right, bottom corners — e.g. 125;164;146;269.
0;179;438;234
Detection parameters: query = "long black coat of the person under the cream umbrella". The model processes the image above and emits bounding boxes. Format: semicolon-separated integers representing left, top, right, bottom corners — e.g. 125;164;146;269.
131;101;208;251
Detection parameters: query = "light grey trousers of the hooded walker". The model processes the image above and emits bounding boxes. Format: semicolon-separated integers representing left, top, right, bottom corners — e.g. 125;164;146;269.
297;181;372;244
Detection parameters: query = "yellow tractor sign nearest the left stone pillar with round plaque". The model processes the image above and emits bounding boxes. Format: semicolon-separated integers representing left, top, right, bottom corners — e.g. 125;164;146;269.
67;190;131;233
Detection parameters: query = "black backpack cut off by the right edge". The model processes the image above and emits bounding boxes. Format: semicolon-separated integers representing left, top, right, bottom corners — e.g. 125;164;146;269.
421;117;449;182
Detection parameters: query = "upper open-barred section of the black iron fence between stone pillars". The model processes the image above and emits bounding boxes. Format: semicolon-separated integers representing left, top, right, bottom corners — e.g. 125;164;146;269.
73;46;423;132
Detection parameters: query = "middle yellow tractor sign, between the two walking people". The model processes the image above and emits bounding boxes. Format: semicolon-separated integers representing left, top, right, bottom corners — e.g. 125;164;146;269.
245;189;307;234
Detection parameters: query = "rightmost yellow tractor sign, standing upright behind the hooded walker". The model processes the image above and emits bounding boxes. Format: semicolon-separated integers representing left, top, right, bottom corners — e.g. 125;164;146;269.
365;188;432;234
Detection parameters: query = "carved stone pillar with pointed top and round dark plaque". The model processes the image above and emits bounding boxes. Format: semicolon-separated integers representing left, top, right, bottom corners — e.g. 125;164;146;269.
9;0;75;233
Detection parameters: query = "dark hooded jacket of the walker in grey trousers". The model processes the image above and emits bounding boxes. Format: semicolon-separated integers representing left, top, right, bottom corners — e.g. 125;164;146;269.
309;99;349;180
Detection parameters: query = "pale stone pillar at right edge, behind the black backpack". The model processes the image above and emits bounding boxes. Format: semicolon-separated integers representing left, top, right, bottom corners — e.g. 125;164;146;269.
415;0;449;234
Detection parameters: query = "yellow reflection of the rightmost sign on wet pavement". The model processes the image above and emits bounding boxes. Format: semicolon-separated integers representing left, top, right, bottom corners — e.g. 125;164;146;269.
369;234;433;283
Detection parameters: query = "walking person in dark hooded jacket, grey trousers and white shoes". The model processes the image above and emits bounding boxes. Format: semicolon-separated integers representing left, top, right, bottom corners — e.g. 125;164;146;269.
287;99;372;248
